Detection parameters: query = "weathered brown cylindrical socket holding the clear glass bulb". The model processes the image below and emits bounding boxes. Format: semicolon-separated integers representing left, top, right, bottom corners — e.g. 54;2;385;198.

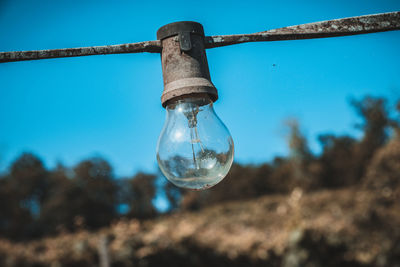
157;21;218;107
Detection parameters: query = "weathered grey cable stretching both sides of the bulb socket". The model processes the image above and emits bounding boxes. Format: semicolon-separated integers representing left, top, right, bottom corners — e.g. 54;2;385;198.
0;11;400;63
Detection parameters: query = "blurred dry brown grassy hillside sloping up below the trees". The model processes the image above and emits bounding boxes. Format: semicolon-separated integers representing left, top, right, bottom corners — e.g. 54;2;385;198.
0;139;400;267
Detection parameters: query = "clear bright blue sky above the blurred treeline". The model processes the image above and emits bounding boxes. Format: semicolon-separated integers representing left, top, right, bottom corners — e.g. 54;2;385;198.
0;0;400;176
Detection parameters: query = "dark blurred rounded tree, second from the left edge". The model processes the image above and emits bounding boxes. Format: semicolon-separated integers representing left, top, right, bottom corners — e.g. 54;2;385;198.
39;158;118;234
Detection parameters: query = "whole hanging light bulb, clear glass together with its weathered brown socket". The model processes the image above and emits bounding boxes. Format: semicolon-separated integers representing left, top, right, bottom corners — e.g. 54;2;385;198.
157;22;234;189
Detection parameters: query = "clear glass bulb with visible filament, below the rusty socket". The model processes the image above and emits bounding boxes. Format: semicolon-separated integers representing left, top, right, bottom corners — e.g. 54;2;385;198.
157;96;234;189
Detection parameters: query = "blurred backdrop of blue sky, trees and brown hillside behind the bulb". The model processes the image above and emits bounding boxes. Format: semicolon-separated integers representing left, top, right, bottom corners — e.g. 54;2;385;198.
0;0;400;267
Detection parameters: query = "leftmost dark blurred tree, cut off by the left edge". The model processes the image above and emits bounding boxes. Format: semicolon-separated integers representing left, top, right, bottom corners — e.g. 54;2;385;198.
0;153;50;239
